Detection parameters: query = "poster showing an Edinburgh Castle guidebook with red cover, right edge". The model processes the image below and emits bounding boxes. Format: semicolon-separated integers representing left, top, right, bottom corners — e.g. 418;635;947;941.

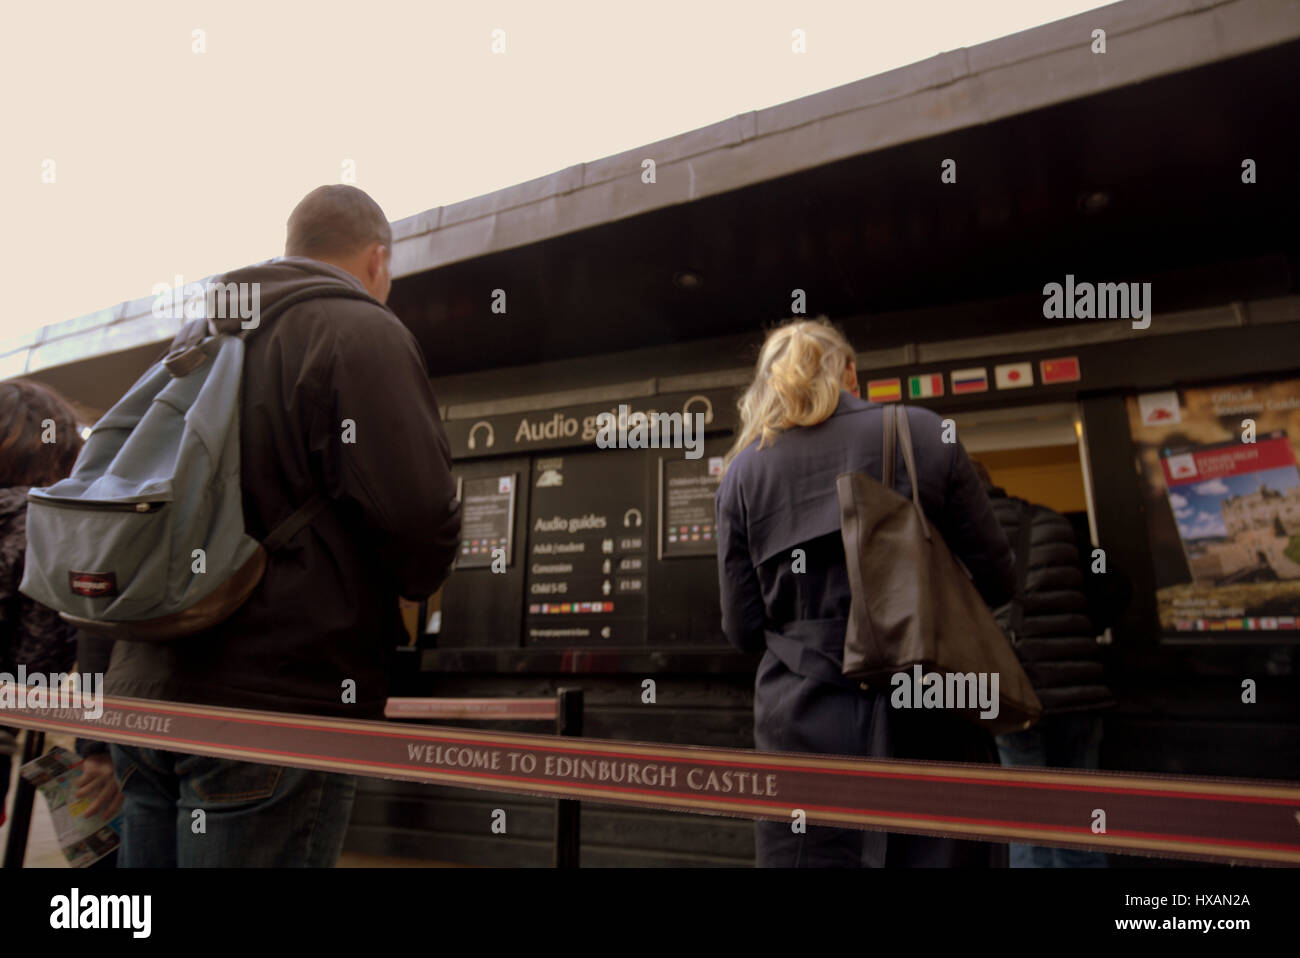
1128;380;1300;634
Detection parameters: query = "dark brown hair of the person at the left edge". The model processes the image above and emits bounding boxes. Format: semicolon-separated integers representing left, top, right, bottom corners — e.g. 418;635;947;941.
0;380;82;489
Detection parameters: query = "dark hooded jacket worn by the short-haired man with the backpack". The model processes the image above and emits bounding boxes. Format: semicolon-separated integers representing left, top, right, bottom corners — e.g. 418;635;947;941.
105;257;460;718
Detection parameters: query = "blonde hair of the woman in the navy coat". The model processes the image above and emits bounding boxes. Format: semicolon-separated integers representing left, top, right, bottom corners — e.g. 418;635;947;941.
725;317;854;465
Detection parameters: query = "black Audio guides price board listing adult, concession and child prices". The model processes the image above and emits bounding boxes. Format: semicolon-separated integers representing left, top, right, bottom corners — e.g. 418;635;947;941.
524;450;649;646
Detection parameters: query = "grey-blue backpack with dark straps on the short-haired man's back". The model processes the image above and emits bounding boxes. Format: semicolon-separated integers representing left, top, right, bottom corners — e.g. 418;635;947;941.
20;283;368;641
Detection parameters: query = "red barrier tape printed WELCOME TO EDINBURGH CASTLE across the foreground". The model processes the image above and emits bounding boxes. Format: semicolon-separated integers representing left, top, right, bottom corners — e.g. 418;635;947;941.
0;695;1300;866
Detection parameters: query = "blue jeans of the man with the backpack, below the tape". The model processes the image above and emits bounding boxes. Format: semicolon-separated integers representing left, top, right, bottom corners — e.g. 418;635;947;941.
112;745;356;868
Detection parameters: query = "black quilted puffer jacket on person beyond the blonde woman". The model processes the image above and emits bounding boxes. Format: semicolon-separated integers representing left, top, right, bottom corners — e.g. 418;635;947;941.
989;487;1114;715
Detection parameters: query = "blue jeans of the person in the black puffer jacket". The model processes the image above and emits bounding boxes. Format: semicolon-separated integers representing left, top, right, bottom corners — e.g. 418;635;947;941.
997;712;1106;868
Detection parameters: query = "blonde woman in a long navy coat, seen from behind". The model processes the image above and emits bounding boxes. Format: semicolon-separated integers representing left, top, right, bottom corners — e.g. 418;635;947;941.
716;320;1015;867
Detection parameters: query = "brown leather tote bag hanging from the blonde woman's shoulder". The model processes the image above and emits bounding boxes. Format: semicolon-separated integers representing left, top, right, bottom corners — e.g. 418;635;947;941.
836;406;1043;734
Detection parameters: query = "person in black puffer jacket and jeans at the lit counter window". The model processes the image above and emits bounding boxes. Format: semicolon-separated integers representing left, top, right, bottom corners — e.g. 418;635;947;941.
975;463;1114;868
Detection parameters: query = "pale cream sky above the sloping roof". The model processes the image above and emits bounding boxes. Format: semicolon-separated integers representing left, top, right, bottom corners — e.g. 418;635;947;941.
0;0;1118;344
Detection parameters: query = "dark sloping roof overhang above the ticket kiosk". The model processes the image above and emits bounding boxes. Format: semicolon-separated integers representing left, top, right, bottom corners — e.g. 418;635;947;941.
0;0;1300;408
